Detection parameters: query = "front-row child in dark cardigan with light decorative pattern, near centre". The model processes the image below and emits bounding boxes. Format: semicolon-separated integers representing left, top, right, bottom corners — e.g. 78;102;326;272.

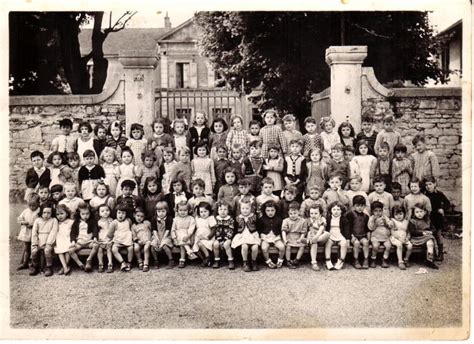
212;202;235;270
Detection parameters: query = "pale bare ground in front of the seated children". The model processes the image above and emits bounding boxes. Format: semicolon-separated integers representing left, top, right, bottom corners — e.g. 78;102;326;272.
10;205;462;328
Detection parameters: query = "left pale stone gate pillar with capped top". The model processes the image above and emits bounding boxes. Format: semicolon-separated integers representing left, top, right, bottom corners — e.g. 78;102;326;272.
119;50;158;135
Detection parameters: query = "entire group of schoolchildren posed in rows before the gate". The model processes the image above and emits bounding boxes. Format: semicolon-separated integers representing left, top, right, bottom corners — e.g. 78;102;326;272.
18;110;449;276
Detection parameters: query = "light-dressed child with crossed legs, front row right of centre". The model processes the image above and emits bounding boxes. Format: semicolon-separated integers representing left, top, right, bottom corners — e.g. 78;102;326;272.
305;204;329;271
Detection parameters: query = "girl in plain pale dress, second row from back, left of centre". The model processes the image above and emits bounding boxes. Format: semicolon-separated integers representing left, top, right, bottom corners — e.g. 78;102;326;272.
191;141;216;195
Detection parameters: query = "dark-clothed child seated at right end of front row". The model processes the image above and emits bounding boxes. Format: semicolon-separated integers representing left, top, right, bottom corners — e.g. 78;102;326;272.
408;203;439;270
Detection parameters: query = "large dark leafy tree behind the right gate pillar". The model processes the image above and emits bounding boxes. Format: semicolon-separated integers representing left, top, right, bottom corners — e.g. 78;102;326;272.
196;12;442;118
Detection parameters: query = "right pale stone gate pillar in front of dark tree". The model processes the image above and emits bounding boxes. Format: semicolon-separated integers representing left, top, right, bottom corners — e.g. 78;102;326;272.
326;46;367;132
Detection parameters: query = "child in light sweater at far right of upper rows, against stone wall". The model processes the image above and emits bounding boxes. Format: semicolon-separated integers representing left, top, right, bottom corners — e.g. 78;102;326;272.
411;135;441;180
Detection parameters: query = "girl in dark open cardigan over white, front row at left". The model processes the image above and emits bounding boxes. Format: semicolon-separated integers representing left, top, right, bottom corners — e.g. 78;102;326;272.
69;203;99;272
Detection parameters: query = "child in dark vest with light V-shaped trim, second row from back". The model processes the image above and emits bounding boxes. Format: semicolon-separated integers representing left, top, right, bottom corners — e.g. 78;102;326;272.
283;141;308;200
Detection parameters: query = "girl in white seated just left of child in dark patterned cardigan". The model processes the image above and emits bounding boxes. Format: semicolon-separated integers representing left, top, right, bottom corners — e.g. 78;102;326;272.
193;202;217;267
